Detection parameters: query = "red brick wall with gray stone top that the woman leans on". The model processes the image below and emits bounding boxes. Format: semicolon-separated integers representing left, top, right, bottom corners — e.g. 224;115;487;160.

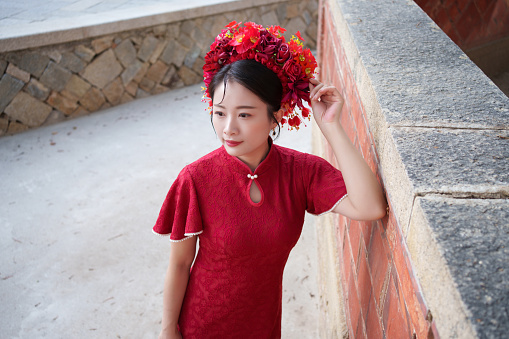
315;0;509;339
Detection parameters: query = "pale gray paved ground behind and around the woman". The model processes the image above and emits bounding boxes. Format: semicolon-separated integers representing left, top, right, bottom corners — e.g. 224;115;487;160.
0;85;318;338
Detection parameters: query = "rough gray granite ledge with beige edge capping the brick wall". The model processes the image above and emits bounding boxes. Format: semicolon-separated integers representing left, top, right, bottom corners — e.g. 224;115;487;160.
330;0;509;338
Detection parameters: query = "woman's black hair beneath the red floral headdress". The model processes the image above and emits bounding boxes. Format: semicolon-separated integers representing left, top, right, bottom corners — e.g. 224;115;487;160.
208;59;283;138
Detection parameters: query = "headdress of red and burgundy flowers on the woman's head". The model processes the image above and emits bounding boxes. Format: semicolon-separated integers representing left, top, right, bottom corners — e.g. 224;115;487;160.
203;21;316;129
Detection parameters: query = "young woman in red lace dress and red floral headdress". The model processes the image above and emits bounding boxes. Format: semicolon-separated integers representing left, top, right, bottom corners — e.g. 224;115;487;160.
153;22;386;339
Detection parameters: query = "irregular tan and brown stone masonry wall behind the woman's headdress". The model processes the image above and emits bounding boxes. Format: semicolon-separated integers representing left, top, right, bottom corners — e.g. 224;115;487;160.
0;0;318;135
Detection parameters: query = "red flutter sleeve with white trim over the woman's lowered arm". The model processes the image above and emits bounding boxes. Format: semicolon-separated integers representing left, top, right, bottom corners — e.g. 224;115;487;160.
152;167;203;241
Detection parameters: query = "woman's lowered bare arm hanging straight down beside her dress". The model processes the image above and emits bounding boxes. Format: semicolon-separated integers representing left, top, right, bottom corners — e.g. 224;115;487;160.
159;237;196;339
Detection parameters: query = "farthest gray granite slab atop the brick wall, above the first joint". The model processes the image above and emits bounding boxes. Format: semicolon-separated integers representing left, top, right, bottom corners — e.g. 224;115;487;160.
338;0;509;129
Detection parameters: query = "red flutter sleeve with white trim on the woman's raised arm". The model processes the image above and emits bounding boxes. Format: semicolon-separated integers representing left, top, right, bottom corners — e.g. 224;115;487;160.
304;154;348;215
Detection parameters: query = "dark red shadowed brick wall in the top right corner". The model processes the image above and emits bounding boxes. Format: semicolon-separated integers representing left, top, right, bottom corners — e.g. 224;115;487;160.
415;0;509;50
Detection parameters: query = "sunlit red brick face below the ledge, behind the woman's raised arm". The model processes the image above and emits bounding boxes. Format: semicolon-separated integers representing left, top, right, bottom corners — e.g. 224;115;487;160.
318;1;438;339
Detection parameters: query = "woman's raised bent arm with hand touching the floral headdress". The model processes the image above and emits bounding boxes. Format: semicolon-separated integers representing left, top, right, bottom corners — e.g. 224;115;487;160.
309;79;387;220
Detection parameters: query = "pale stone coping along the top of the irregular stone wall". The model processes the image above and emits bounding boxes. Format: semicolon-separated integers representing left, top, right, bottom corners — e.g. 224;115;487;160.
0;0;287;53
